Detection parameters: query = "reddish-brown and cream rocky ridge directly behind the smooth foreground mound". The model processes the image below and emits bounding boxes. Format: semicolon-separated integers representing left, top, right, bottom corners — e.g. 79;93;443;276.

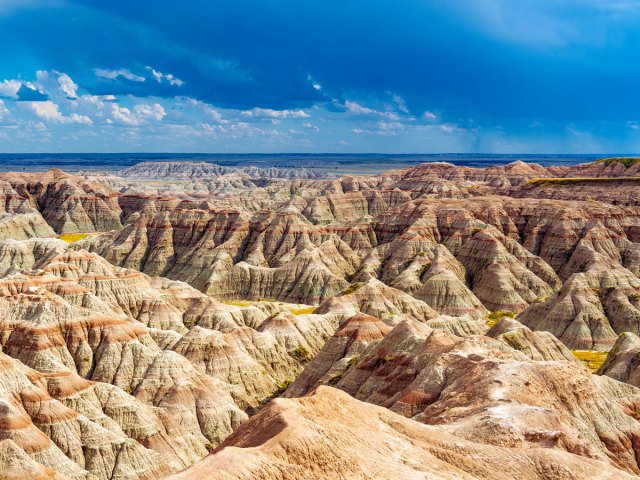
284;315;640;474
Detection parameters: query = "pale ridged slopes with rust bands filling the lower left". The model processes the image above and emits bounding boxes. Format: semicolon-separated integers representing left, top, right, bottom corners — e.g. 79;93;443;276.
0;239;335;479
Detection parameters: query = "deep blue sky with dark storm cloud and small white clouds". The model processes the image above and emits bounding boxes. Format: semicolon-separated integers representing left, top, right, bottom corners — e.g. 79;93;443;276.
0;0;640;153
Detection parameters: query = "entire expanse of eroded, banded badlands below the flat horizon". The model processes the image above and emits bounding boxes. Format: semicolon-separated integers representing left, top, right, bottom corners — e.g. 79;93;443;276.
0;158;640;480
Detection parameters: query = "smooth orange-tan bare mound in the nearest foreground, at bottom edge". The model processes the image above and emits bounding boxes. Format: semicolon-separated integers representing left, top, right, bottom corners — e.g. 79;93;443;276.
168;387;635;480
